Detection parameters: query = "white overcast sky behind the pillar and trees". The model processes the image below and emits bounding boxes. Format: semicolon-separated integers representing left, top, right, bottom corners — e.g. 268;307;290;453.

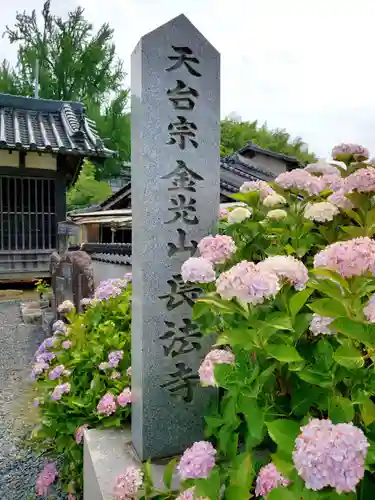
0;0;375;156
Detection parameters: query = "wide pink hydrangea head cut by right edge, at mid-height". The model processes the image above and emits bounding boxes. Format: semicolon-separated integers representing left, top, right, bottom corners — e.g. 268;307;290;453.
314;236;375;278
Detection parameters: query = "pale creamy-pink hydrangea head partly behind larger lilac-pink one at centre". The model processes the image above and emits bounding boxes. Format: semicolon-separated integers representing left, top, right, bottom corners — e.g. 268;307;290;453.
257;255;309;290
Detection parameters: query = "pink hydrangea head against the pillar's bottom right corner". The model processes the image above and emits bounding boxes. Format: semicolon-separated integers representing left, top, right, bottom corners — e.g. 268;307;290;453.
177;441;216;480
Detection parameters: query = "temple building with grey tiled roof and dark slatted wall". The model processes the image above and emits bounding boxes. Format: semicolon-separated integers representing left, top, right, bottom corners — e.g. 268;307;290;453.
0;93;116;281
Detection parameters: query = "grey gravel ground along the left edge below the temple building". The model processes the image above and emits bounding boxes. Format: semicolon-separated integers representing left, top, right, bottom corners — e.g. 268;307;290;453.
0;301;66;500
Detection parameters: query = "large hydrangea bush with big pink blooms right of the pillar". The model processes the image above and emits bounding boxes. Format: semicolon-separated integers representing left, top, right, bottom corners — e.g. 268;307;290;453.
129;144;375;500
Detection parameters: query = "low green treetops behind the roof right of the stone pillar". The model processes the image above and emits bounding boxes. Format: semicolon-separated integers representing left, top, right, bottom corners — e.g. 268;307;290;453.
220;118;315;162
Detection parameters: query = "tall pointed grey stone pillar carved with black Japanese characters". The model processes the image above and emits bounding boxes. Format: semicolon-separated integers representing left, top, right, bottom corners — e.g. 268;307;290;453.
131;15;220;460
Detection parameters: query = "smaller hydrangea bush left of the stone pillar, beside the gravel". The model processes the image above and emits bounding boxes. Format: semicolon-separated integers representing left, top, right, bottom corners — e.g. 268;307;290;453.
32;276;131;500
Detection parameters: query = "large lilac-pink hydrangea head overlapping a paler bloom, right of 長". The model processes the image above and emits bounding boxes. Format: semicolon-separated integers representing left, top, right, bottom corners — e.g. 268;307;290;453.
216;260;280;305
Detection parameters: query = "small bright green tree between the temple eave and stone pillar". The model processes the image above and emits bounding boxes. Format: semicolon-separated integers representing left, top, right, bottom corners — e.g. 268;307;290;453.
67;161;112;210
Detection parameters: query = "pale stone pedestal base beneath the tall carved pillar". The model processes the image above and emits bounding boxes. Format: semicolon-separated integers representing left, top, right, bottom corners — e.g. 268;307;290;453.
83;427;178;500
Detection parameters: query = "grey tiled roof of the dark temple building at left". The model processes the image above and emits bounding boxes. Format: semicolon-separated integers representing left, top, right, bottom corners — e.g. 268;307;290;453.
0;93;116;158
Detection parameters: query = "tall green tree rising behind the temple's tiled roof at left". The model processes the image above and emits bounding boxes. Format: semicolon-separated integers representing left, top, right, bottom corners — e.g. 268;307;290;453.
0;0;130;178
